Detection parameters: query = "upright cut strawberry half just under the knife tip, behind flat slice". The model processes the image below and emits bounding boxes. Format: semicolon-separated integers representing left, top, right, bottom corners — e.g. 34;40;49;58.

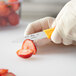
22;39;37;55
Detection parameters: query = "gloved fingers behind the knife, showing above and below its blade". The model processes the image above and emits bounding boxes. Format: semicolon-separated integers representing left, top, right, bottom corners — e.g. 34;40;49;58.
24;17;54;46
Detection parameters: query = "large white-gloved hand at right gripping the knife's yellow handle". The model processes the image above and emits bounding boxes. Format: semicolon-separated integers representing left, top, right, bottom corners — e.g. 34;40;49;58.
51;0;76;45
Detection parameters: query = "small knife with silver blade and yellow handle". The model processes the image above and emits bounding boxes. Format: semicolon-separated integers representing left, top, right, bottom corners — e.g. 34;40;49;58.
25;28;55;40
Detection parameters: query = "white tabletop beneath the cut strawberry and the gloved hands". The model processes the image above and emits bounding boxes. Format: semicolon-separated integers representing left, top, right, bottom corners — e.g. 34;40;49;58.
0;20;76;76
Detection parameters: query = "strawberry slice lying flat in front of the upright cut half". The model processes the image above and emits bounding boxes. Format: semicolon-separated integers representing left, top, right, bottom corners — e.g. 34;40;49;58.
17;49;33;58
